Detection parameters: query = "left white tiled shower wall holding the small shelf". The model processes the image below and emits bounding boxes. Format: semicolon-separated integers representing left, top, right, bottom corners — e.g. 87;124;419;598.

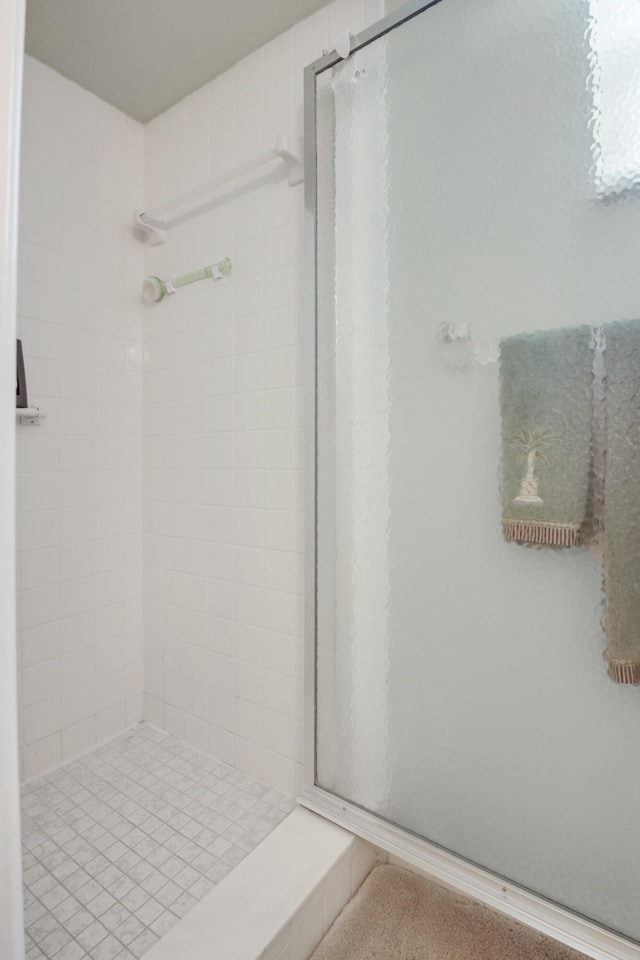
17;57;144;778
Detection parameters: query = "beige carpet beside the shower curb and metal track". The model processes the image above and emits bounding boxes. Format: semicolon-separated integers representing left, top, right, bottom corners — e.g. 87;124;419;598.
311;865;586;960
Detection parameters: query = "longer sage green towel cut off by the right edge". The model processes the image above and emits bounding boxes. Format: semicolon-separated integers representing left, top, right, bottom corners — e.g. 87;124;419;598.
604;320;640;683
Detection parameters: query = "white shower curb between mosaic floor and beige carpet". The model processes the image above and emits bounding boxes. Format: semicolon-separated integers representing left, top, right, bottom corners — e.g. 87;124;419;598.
145;807;376;960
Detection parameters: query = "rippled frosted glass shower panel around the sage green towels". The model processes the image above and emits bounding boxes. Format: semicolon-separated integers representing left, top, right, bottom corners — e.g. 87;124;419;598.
316;0;640;939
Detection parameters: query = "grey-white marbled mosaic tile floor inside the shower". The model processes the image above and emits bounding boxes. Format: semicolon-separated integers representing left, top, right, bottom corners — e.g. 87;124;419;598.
22;723;294;960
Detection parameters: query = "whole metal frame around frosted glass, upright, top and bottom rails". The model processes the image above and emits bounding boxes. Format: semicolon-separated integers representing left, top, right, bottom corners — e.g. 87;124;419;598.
298;0;640;960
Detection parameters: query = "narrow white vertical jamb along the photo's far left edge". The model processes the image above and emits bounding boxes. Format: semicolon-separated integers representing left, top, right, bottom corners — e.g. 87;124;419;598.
0;0;24;948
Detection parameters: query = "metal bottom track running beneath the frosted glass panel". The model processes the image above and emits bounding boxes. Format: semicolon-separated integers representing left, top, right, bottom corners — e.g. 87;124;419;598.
298;786;640;960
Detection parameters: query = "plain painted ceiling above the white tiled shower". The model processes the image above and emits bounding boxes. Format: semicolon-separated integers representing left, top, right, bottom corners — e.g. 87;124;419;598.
25;0;327;123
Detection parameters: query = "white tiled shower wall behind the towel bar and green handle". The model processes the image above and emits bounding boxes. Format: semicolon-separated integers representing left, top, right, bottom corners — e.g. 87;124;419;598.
144;0;384;792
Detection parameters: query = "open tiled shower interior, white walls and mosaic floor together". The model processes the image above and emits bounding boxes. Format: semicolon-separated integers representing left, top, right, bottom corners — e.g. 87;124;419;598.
7;0;350;960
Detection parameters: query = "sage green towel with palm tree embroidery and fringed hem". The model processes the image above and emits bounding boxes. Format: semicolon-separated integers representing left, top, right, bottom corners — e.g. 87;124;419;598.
500;326;592;547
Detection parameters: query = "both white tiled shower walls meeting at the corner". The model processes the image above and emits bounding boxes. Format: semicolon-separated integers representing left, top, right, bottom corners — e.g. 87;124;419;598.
18;0;383;793
